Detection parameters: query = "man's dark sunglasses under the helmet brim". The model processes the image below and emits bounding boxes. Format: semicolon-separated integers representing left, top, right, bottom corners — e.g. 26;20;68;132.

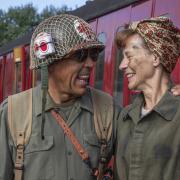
65;48;100;62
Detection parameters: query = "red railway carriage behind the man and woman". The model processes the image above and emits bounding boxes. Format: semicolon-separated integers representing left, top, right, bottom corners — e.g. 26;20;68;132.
0;0;180;105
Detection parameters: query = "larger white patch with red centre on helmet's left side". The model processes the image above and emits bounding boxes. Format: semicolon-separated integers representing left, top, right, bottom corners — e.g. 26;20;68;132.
34;32;55;59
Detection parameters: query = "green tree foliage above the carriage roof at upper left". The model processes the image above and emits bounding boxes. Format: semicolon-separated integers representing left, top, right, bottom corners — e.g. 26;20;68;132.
0;4;69;46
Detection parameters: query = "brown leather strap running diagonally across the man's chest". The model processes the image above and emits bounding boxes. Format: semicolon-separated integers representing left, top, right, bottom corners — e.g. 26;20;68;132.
51;110;98;176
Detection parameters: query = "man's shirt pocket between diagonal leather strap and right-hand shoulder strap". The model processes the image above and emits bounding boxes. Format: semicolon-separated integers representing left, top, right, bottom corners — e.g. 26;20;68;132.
84;134;101;167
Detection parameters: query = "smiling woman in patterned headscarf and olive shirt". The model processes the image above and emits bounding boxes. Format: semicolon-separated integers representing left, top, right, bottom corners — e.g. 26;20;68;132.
115;17;180;180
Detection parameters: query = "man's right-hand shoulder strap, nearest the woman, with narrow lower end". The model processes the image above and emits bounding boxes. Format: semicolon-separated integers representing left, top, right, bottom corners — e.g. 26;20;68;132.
91;89;114;180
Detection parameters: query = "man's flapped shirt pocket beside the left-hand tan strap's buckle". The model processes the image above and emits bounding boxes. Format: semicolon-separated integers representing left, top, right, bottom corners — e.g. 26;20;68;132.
24;135;54;180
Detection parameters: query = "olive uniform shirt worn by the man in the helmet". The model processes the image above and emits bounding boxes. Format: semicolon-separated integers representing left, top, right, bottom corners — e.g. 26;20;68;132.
0;87;120;180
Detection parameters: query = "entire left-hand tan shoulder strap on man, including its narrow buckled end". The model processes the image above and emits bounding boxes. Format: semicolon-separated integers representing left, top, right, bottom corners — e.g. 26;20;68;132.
8;89;32;180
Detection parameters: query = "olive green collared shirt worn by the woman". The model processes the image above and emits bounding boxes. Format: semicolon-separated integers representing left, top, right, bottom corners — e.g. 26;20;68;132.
115;91;180;180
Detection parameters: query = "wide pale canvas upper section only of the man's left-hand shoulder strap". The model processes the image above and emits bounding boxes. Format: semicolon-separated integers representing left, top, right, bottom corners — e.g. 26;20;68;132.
8;89;32;145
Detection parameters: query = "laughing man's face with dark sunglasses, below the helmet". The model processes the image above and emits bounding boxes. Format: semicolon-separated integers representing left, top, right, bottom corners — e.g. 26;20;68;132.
49;49;99;96
